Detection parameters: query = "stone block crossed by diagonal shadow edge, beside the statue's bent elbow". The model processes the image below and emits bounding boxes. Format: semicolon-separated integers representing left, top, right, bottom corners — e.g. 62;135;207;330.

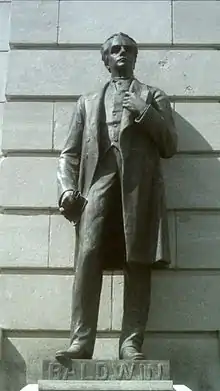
175;102;220;152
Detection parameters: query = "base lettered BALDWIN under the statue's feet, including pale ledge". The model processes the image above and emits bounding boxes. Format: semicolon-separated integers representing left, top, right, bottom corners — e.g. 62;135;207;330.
38;360;173;391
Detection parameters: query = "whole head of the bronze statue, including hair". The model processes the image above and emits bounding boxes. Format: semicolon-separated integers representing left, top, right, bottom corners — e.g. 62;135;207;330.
101;33;138;74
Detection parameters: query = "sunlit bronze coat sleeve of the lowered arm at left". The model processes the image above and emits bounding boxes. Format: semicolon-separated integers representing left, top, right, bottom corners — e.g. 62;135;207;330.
57;97;85;205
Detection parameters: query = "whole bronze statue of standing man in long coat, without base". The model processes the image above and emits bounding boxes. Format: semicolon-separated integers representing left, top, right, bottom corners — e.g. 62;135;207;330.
56;33;177;362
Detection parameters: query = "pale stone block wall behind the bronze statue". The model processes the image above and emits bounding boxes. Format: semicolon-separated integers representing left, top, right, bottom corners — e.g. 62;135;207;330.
0;0;220;391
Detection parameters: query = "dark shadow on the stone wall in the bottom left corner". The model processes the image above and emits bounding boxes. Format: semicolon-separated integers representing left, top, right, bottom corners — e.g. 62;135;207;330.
0;338;27;391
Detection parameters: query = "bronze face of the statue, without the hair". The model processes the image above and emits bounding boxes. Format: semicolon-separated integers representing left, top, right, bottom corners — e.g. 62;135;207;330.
108;35;136;75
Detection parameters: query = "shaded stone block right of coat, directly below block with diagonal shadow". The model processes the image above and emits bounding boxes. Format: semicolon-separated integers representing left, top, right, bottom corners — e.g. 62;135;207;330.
163;155;220;209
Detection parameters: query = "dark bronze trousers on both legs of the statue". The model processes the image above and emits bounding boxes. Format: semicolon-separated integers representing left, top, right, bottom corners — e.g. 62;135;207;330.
70;146;151;357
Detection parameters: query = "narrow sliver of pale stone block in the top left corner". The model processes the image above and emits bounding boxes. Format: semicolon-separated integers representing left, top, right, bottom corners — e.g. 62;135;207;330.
0;2;10;50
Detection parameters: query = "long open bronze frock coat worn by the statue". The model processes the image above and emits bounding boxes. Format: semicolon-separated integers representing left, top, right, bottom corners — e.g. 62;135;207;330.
58;79;177;269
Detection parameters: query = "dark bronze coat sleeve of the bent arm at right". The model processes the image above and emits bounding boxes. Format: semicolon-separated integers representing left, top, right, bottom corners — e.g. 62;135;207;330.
135;89;177;159
